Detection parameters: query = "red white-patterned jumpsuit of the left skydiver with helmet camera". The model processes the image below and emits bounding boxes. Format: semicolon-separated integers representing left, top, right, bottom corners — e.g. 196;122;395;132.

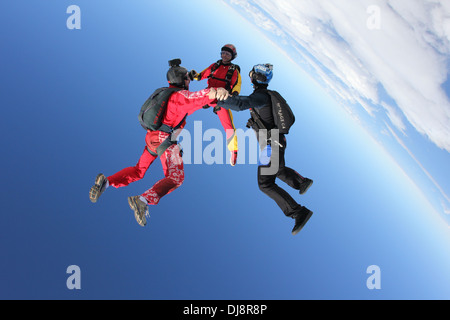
107;89;214;205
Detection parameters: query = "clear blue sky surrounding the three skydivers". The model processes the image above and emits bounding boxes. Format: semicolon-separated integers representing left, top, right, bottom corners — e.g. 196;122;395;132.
0;0;450;299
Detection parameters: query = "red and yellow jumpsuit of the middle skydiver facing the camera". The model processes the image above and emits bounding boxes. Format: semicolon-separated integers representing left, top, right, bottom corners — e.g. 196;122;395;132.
195;60;241;151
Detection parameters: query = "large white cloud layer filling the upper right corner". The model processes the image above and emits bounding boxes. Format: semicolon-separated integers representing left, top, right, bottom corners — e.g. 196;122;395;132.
225;0;450;152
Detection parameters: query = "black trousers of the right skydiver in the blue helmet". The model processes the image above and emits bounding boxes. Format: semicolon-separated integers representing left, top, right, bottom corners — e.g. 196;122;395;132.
258;137;304;217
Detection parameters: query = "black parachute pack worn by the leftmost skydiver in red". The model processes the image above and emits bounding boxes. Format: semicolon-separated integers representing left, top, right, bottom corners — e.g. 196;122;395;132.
138;87;187;156
